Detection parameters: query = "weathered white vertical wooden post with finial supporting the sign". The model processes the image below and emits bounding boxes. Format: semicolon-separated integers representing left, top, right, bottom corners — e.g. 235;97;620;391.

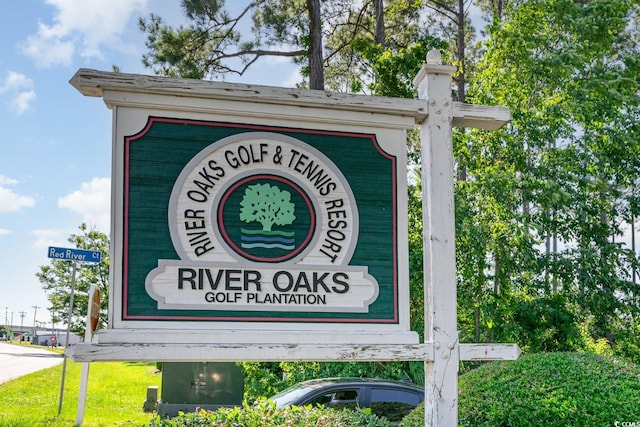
414;50;460;427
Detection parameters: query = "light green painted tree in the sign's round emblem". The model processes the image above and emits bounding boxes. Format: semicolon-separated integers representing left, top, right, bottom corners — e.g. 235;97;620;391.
240;184;296;231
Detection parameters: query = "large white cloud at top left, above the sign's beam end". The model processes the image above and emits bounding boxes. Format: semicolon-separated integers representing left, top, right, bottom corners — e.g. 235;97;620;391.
21;0;148;67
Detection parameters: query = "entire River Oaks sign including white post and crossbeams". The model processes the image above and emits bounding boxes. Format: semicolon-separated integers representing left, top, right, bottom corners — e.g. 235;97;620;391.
66;55;520;426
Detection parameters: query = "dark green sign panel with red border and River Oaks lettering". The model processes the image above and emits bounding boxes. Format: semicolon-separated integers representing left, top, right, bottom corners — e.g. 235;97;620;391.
121;117;399;324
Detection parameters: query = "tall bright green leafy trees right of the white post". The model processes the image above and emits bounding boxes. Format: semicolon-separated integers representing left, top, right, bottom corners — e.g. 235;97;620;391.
464;0;640;356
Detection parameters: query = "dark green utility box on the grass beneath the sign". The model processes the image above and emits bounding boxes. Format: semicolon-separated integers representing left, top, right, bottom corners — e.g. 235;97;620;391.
158;362;244;417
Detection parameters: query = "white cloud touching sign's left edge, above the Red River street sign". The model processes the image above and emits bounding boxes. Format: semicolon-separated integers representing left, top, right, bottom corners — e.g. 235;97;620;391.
58;178;111;233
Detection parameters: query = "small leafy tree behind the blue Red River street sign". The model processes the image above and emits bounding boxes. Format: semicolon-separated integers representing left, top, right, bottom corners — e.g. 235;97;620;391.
36;224;110;334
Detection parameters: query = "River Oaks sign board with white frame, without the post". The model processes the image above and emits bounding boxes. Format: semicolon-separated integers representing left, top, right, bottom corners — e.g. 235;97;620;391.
72;70;425;344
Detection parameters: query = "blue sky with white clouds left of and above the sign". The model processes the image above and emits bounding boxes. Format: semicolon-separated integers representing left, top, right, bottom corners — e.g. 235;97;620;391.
0;0;300;327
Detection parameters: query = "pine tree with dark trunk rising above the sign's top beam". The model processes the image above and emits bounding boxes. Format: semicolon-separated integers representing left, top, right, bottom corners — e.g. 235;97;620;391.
139;0;438;92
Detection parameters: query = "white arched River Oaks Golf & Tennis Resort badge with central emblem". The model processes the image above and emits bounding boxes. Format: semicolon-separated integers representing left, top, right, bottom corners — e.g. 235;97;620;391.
168;132;359;266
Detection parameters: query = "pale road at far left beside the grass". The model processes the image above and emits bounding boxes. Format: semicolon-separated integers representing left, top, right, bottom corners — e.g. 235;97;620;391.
0;342;63;384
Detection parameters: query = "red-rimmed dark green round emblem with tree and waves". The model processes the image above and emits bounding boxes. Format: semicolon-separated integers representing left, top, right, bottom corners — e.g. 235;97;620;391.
217;174;316;262
